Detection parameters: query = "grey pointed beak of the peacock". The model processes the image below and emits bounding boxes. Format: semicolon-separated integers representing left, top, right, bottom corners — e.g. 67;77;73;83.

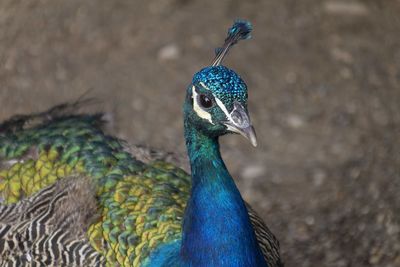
224;102;257;147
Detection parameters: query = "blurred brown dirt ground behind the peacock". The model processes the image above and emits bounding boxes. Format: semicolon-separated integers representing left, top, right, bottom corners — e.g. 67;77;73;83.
0;0;400;267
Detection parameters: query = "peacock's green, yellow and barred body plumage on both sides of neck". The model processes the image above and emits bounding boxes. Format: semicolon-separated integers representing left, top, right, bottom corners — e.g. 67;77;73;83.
0;103;282;267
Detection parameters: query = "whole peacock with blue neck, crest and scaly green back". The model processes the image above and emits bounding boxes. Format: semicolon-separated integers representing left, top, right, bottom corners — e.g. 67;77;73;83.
0;20;283;267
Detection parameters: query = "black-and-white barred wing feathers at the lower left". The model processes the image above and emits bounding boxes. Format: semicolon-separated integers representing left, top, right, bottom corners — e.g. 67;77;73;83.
0;177;105;267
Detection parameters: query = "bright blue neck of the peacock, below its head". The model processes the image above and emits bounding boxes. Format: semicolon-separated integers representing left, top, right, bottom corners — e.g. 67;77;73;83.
180;121;266;267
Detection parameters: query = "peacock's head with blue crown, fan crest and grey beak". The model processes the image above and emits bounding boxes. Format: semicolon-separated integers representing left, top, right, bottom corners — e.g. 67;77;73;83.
184;20;257;146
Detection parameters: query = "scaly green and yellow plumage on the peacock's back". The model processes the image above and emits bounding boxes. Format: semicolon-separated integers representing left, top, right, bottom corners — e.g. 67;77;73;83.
0;112;190;266
